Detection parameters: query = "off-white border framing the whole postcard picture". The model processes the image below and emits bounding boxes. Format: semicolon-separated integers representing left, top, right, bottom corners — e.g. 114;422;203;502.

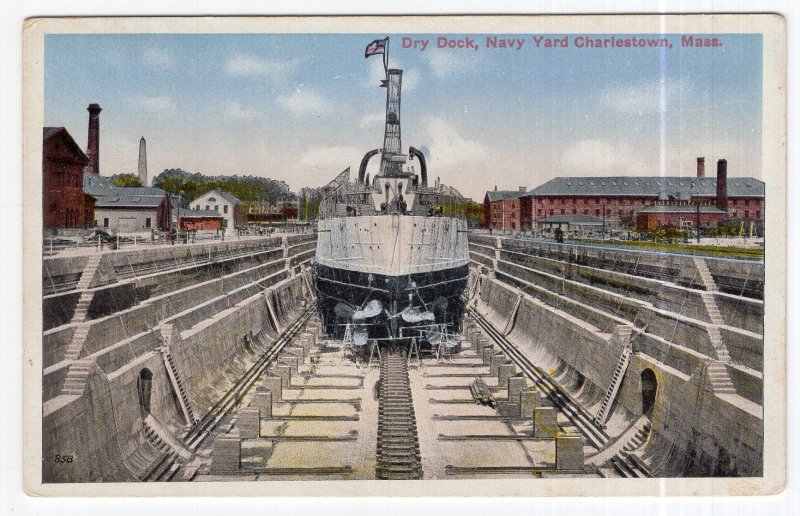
23;14;787;497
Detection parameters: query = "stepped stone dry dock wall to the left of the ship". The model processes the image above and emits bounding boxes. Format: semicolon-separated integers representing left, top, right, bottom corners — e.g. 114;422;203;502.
42;235;314;482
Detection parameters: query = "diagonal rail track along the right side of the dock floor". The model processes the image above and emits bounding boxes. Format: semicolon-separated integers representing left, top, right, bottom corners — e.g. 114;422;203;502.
468;307;652;478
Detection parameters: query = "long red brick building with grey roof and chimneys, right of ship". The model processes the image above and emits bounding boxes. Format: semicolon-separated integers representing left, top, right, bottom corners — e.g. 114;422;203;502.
484;158;764;231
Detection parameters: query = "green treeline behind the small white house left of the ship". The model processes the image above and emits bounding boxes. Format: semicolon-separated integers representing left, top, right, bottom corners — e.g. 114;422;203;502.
153;168;296;204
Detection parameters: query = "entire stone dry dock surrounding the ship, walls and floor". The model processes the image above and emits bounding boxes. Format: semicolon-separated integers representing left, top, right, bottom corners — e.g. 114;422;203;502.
42;230;764;482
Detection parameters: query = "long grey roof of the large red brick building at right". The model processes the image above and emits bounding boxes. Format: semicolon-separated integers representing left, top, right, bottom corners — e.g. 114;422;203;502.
531;176;764;200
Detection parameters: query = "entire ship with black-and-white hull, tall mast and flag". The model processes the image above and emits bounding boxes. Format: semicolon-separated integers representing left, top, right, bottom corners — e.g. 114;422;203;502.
314;38;469;346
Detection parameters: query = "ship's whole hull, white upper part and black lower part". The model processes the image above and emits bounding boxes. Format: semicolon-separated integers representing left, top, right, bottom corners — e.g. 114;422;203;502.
314;215;469;341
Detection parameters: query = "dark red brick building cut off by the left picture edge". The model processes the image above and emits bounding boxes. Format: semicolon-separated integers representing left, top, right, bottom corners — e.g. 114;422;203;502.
42;127;94;229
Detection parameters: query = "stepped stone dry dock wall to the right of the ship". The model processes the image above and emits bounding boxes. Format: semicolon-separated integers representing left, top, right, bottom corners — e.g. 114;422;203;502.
470;236;764;476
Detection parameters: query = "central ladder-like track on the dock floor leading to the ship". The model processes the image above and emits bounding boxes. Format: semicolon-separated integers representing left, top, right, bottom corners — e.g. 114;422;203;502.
375;352;422;480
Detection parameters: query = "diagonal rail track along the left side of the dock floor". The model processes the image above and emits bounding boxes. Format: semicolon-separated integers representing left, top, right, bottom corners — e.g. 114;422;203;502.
144;305;316;482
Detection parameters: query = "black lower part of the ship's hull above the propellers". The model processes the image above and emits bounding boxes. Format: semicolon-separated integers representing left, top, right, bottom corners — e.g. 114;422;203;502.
314;264;468;340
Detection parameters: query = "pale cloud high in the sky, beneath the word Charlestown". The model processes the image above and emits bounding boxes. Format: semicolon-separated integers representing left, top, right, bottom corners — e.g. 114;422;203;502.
600;79;695;115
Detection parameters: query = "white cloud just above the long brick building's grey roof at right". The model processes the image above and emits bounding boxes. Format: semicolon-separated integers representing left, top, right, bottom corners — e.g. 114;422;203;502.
561;139;654;176
